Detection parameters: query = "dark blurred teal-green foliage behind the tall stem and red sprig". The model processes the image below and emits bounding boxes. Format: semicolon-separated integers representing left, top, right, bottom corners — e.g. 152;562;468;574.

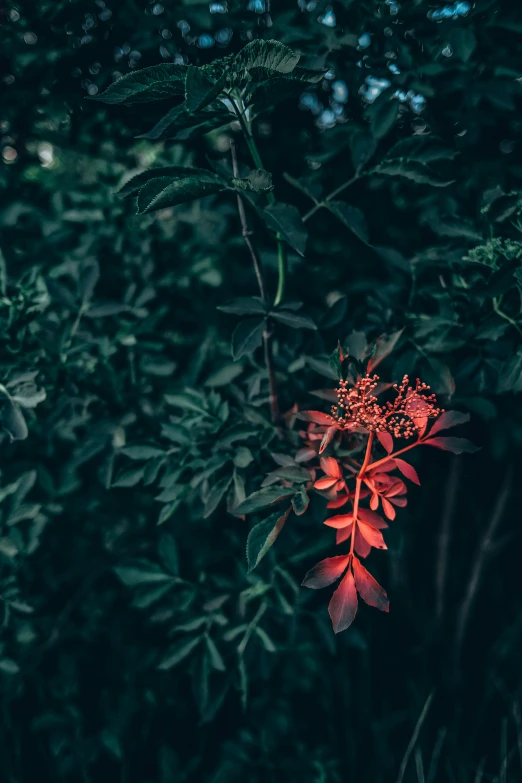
0;0;522;783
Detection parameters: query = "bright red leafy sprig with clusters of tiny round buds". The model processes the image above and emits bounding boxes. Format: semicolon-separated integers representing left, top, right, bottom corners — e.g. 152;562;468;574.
298;375;475;633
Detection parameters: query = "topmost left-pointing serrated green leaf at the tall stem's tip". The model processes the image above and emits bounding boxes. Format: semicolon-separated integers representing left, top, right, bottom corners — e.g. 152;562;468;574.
90;63;187;104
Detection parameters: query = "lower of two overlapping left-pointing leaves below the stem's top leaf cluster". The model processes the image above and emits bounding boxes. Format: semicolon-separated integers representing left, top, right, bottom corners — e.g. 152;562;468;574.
137;172;226;215
